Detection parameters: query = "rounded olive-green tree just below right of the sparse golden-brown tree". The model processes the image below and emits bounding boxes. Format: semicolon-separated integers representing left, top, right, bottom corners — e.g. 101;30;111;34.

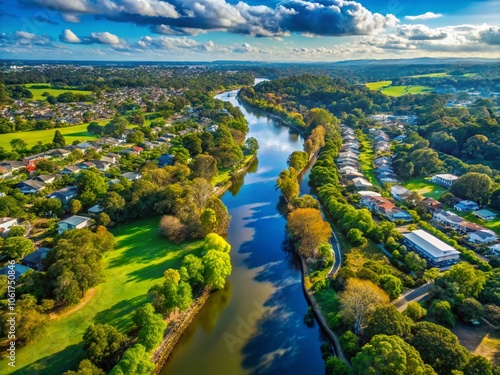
365;305;413;339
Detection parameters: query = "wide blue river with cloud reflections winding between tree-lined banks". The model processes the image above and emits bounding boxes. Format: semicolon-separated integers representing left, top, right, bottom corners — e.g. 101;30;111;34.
161;80;324;375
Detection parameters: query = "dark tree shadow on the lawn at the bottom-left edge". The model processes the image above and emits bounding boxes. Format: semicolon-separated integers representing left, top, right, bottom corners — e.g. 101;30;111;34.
12;343;85;375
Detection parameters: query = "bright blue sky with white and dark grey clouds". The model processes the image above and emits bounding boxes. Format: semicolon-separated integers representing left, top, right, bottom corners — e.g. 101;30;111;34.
0;0;500;61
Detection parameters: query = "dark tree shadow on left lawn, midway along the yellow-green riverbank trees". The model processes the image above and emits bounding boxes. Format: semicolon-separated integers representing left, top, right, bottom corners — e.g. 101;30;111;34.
94;294;148;333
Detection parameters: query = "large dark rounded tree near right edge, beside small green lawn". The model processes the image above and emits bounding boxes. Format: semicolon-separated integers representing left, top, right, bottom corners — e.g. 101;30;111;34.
450;172;492;206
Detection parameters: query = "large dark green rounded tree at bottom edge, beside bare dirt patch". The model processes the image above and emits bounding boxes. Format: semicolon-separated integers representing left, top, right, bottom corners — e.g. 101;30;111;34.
409;322;469;375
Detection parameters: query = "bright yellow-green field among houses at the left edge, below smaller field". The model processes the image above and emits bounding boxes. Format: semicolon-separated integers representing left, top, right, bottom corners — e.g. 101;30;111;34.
0;125;98;150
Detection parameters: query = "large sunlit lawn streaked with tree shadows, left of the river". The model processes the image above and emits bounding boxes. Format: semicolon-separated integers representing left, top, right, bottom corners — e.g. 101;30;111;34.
0;217;201;375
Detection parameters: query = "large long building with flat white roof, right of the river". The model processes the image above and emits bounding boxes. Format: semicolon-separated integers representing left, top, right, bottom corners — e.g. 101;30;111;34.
403;229;460;267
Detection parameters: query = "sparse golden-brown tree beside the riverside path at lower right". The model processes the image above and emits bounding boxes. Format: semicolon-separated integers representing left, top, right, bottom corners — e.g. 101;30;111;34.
340;278;389;334
